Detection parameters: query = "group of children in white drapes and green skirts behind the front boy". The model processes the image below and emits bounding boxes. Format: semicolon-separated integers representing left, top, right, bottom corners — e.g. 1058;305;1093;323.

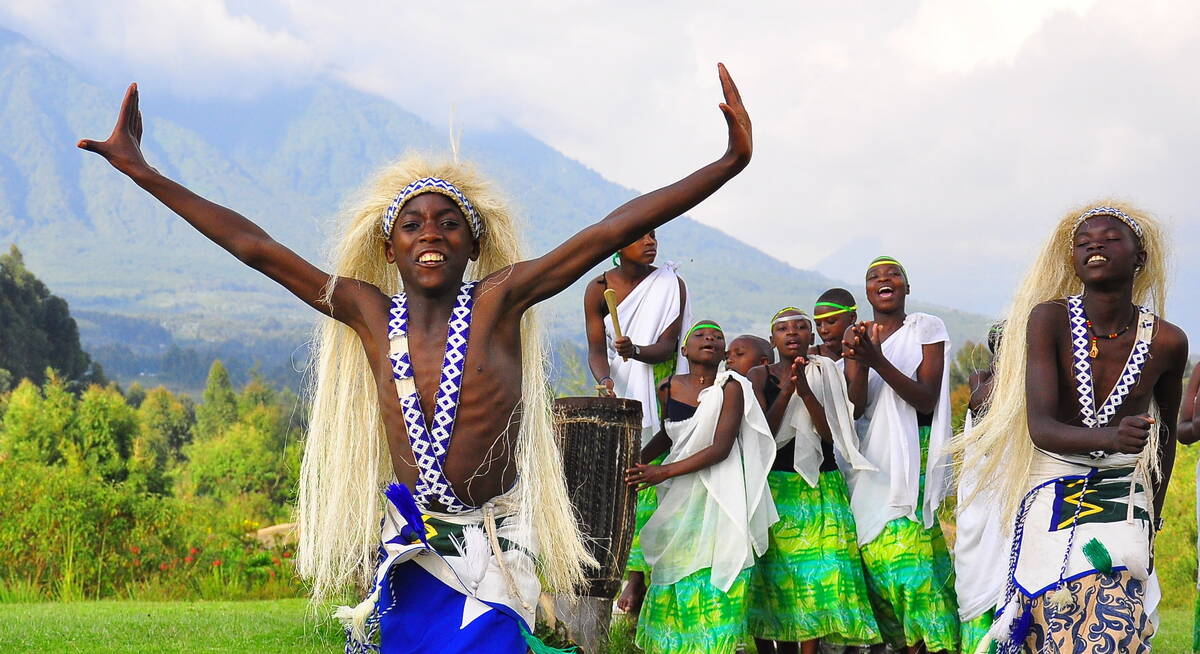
595;246;973;654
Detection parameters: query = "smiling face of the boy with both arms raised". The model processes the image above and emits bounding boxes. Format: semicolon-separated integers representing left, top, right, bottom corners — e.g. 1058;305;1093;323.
384;193;479;292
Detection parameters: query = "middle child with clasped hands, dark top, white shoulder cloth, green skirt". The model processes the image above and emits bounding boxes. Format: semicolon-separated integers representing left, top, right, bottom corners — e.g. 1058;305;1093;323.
749;307;880;654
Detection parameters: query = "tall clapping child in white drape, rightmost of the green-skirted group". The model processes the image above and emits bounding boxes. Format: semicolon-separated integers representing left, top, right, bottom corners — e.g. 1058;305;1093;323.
842;257;959;653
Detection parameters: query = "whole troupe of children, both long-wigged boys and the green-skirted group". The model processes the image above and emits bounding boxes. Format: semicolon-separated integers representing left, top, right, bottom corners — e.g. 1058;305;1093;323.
79;66;1180;654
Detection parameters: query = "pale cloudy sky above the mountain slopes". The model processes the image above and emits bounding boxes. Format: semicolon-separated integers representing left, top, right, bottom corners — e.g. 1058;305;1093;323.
0;0;1200;328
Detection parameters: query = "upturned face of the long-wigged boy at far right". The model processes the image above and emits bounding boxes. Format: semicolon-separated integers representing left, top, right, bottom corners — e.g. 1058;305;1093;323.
1072;216;1146;283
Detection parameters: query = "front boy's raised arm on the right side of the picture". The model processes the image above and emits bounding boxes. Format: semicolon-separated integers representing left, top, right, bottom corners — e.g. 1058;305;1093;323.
508;65;752;311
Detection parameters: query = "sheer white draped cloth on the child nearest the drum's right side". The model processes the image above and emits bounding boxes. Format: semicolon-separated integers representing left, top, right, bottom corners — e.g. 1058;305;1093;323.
641;371;779;592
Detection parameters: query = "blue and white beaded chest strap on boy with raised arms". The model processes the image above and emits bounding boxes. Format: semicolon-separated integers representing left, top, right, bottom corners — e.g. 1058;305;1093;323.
388;282;475;514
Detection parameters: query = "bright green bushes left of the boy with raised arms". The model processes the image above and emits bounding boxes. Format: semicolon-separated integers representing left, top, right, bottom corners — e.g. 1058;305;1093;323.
0;362;314;600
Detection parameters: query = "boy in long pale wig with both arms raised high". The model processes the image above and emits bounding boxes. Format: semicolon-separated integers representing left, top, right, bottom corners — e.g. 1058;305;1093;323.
79;66;751;653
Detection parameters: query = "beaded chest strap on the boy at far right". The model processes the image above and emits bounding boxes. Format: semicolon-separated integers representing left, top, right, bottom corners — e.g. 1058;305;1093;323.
1067;295;1154;458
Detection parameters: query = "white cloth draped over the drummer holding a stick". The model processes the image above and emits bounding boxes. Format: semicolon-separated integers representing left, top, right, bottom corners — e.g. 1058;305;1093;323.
604;262;691;446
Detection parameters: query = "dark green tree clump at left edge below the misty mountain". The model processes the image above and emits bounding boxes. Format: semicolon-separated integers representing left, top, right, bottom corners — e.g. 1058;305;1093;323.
0;245;104;391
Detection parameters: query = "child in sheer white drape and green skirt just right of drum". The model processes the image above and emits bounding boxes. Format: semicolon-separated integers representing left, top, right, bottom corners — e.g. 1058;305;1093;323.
626;320;778;654
